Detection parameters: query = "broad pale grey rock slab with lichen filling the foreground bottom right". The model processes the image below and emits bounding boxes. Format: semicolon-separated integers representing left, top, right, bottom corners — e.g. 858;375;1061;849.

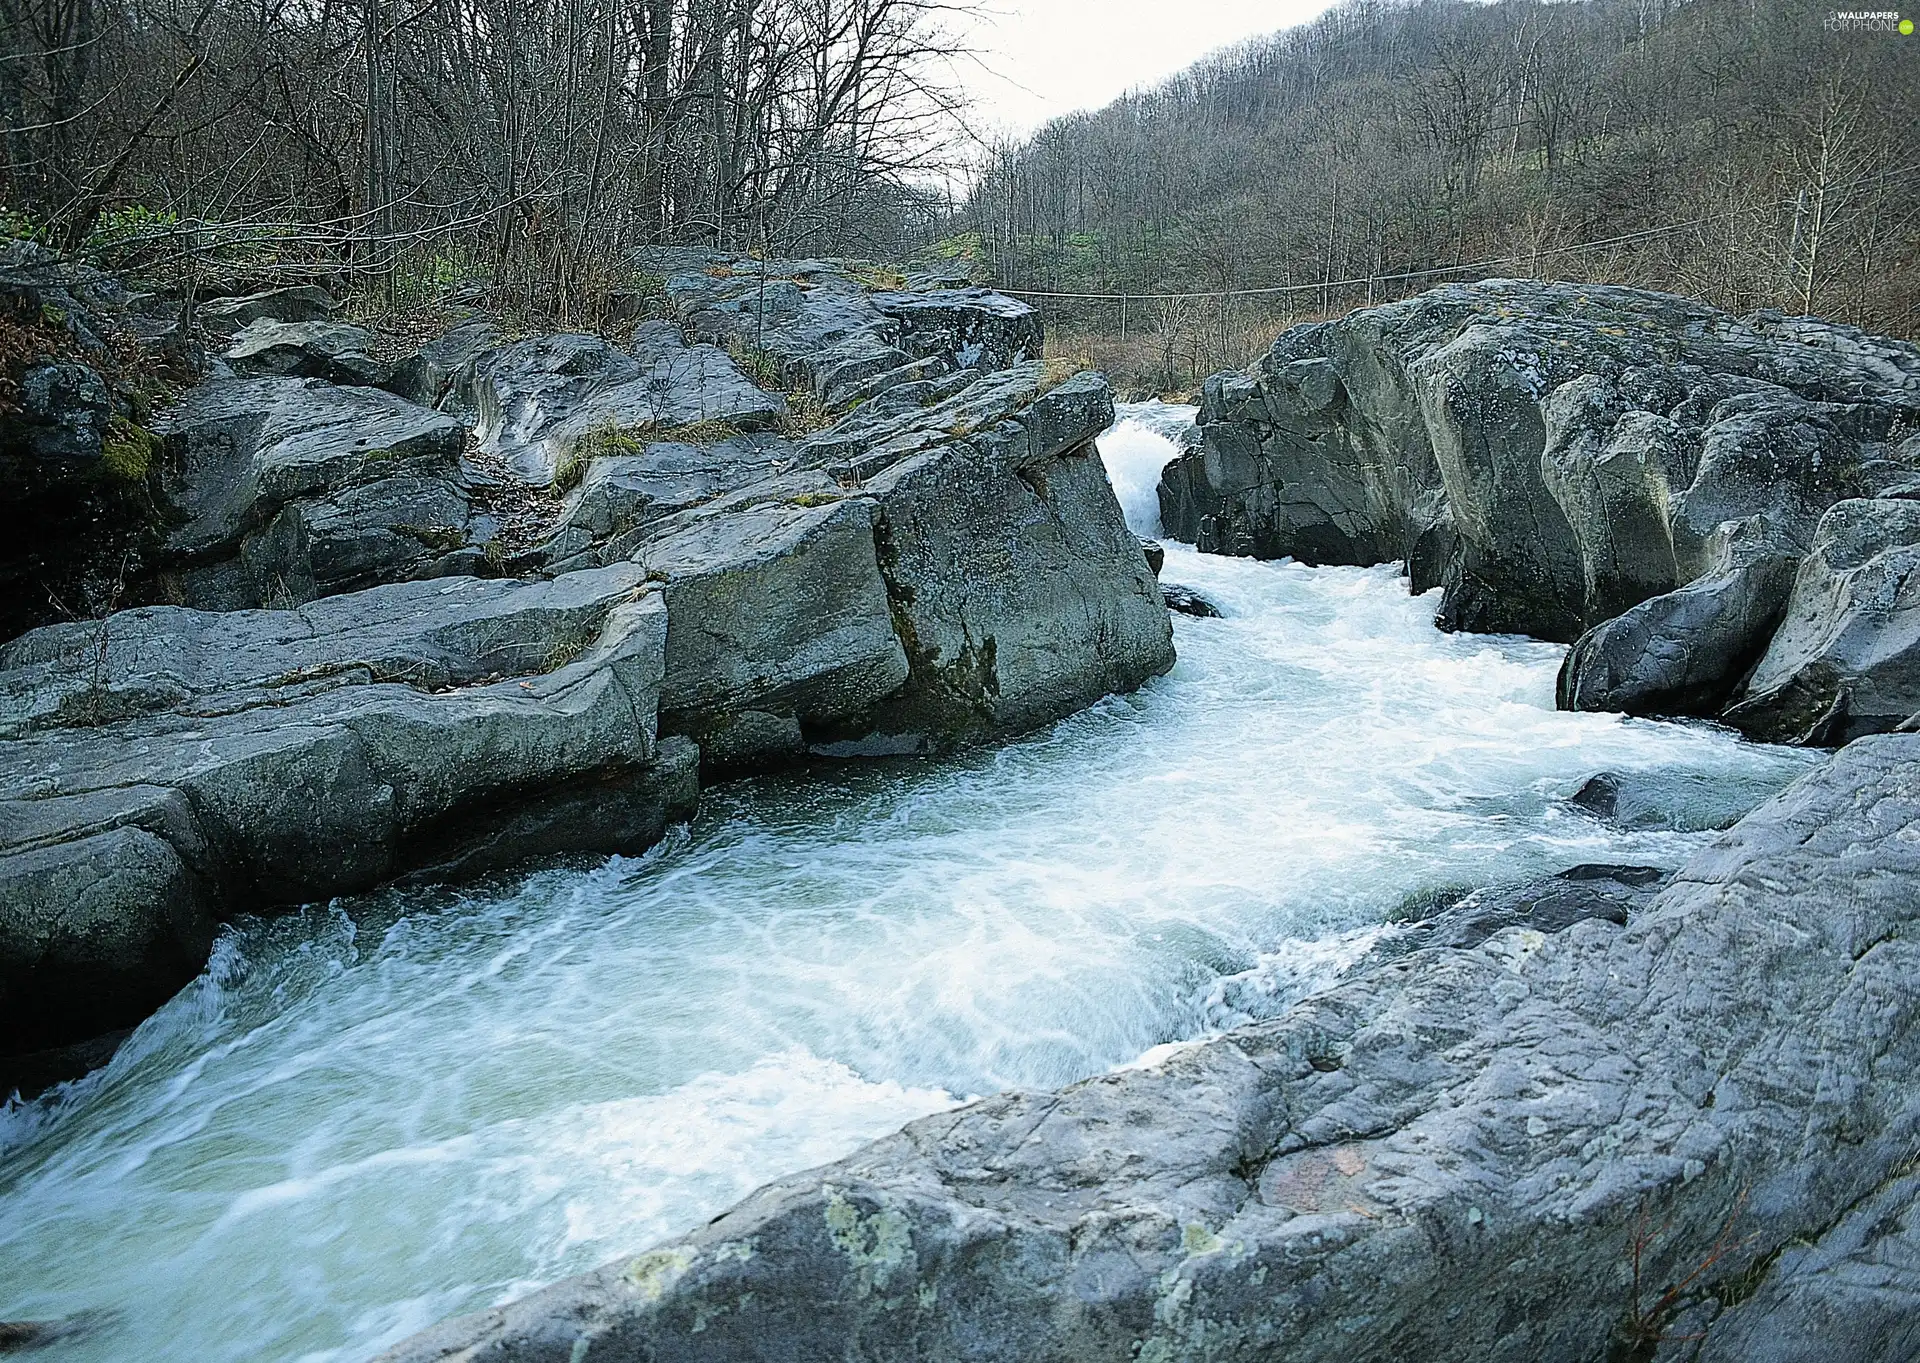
374;735;1920;1363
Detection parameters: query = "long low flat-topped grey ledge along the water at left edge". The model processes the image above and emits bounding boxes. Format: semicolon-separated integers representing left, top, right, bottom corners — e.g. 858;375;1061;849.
0;564;697;1052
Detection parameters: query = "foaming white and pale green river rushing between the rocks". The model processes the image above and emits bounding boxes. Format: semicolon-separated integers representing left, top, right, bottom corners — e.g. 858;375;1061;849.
0;409;1812;1363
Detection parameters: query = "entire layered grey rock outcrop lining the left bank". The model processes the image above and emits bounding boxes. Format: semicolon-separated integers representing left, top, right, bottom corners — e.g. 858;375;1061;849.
0;265;1173;1079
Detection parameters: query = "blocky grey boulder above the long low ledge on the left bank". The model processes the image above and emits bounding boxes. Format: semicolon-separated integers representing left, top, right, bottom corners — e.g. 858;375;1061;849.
156;378;468;610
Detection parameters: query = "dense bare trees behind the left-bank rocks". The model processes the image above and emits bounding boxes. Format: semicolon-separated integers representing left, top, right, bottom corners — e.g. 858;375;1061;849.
0;0;954;321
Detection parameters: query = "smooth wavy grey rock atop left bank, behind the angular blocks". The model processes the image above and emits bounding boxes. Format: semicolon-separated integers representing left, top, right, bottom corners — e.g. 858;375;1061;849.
459;323;787;486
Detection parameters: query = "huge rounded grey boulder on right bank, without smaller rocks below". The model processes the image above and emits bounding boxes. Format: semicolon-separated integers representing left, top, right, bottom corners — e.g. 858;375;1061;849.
1162;280;1920;652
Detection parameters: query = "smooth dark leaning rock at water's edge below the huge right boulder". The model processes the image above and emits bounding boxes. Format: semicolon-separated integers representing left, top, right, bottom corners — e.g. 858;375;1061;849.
1555;516;1803;716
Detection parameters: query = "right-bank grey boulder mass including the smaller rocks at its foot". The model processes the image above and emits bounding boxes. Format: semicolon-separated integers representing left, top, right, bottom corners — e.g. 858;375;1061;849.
1160;280;1920;743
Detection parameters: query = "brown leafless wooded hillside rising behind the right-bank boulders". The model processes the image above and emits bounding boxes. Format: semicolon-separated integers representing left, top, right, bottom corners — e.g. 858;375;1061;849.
948;0;1920;386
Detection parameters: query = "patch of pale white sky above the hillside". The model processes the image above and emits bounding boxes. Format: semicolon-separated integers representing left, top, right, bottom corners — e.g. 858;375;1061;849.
954;0;1329;132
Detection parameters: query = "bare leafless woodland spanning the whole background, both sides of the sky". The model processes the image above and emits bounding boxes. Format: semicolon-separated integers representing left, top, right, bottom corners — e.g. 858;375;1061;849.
0;0;1920;370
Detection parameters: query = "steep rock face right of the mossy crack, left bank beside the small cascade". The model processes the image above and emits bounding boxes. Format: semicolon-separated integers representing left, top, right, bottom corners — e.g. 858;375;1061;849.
816;363;1173;749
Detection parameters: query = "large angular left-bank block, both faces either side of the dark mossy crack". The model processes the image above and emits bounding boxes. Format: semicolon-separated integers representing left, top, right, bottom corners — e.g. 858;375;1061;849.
572;363;1173;766
